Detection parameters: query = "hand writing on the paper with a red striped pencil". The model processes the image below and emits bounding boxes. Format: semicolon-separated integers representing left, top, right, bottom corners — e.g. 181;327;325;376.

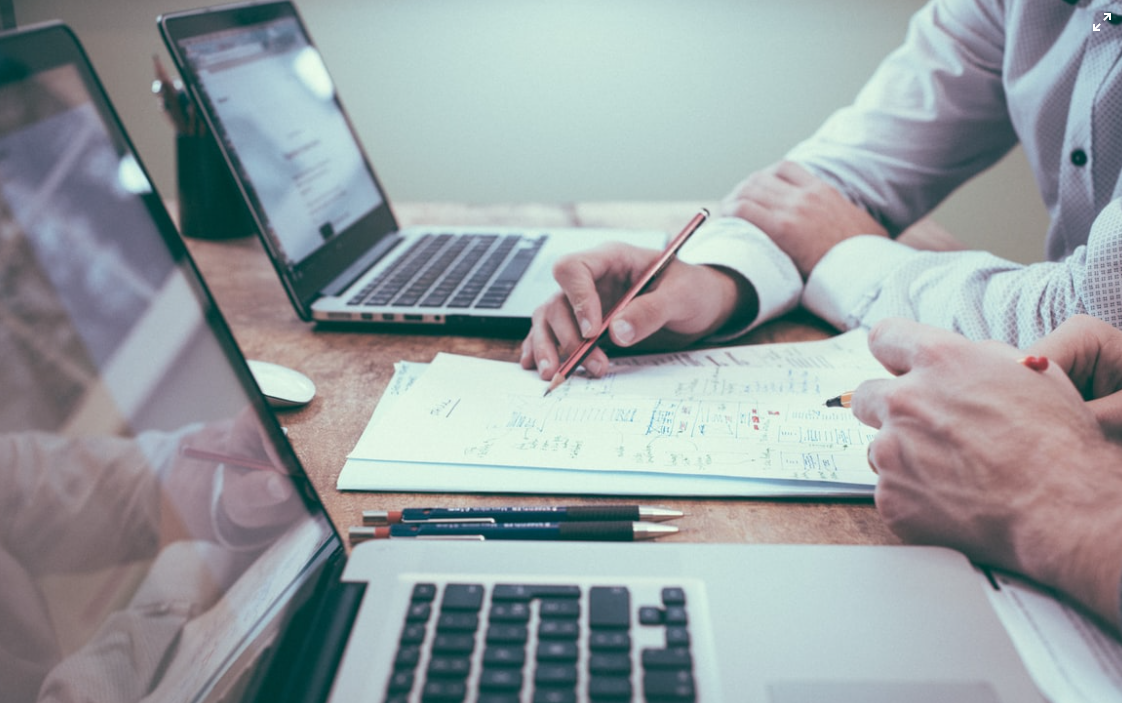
521;243;755;379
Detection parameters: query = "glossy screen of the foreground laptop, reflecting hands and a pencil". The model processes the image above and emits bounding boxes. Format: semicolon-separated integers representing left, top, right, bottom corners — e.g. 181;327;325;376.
0;25;338;702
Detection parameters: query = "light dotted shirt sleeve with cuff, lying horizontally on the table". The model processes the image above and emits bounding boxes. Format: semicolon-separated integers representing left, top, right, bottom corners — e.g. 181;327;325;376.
802;198;1122;346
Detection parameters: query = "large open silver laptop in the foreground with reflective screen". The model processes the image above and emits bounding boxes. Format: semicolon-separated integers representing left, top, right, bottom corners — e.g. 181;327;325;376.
0;24;1042;703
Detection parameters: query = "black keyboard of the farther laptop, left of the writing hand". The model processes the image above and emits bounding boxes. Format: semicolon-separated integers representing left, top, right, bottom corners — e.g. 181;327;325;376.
349;234;546;309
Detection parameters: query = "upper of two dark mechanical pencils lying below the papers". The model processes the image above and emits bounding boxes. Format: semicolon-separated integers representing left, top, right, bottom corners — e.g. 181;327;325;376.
362;506;683;525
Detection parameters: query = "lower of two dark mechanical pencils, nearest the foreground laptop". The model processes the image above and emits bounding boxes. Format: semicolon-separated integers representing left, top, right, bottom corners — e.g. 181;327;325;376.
348;521;678;543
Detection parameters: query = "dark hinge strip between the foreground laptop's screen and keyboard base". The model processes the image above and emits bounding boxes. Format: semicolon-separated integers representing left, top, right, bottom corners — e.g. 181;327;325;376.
254;552;366;703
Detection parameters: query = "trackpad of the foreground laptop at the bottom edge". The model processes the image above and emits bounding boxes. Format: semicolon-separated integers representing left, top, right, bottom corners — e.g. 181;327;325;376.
767;681;999;703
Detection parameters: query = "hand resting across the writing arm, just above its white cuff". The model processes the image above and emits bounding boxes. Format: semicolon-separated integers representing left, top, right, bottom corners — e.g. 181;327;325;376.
721;161;888;279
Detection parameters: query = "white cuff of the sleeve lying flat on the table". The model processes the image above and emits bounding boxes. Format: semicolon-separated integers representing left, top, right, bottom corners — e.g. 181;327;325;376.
802;234;917;330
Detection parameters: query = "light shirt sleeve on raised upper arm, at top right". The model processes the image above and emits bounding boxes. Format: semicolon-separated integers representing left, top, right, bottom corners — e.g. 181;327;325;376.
787;0;1017;237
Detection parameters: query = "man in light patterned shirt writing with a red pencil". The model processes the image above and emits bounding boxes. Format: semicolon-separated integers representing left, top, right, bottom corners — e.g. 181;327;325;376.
521;0;1122;379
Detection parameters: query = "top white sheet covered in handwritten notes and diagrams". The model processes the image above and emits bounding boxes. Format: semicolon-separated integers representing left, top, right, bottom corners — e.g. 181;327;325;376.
350;333;885;484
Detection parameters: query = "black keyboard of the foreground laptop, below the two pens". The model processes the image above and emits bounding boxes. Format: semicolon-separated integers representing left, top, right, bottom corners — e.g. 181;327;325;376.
384;583;697;703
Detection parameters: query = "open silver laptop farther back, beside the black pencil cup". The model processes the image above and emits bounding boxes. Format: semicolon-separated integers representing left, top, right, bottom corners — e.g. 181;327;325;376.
159;1;664;334
